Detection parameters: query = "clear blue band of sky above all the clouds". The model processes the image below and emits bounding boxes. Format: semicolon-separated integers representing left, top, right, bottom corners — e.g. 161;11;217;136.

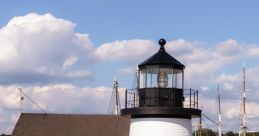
0;0;259;45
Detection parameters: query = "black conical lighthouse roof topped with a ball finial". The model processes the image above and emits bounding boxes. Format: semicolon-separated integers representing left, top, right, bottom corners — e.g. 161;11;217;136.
139;39;185;69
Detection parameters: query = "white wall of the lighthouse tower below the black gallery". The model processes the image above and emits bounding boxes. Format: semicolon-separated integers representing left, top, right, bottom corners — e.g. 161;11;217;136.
130;118;192;136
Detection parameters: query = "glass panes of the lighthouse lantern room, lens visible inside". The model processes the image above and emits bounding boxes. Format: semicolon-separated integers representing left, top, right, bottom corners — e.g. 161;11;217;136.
139;66;183;89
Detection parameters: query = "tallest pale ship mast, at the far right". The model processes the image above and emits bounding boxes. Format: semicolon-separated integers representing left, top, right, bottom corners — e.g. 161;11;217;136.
239;62;247;136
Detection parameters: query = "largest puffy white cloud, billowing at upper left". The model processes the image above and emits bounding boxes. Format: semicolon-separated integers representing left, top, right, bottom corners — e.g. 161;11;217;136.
0;13;93;83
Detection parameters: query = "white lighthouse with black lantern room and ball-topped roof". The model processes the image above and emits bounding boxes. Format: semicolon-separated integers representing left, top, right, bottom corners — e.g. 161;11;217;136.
121;39;201;136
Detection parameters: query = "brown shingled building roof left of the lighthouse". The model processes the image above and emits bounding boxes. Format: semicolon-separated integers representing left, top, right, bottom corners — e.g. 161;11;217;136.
12;113;130;136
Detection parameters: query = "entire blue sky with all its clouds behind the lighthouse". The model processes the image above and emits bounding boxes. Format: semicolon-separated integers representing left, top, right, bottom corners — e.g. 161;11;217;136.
0;0;259;133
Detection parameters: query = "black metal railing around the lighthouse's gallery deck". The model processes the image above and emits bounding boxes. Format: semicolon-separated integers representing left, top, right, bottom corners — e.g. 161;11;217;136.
125;88;199;109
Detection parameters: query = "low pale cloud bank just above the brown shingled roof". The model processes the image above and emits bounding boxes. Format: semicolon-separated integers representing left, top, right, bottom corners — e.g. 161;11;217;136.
0;84;125;133
